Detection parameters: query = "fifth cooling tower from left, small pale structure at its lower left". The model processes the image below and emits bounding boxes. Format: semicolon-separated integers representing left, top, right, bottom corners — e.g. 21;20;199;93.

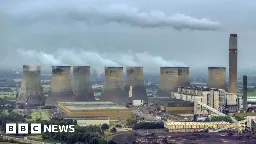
125;67;148;101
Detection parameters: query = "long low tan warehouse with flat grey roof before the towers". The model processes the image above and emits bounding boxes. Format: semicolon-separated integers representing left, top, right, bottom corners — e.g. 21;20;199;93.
58;102;132;121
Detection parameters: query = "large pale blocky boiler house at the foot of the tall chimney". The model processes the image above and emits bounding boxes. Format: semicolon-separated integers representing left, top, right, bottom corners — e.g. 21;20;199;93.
171;87;238;115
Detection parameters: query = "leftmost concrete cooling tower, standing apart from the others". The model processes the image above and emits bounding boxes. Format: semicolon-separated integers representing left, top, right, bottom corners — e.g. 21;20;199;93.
16;65;45;107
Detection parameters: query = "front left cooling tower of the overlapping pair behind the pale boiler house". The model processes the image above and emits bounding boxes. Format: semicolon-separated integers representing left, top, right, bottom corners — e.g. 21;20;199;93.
157;67;179;97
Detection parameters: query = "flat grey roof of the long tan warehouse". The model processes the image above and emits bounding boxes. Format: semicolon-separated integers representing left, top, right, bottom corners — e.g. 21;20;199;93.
58;102;128;110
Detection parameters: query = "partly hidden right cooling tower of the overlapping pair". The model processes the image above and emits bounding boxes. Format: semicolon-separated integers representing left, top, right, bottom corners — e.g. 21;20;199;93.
178;67;190;86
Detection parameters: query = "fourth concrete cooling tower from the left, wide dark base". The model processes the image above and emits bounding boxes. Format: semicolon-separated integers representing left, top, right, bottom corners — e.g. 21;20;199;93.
100;67;128;105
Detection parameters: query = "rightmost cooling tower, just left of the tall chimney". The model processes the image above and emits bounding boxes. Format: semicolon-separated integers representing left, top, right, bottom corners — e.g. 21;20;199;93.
207;67;227;90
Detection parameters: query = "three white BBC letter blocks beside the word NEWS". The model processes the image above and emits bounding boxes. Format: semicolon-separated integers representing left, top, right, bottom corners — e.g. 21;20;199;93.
5;123;41;134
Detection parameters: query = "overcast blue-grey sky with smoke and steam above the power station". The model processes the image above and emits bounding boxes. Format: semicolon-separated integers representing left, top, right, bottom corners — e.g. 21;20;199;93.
0;0;256;72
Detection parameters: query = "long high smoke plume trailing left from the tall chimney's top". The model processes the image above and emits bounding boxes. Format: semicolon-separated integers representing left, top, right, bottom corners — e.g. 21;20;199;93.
7;0;220;30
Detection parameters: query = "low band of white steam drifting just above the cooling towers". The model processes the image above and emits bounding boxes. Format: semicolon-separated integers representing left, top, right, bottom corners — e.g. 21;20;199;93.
17;49;187;72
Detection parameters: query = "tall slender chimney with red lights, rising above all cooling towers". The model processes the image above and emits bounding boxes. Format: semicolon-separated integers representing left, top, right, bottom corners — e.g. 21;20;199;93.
228;34;238;94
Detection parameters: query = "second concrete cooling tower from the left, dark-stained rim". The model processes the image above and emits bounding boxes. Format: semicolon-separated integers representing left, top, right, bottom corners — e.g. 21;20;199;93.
45;66;75;106
